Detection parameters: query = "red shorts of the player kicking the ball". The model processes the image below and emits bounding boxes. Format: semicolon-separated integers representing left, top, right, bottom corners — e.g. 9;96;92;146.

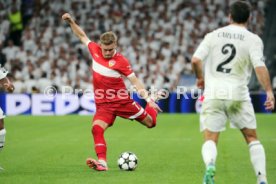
93;99;147;126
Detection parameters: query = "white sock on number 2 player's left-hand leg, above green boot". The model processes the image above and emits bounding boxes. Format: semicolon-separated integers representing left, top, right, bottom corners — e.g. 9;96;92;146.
201;140;217;168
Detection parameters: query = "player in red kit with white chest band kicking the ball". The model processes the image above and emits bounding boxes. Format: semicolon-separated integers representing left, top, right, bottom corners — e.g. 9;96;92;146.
62;13;161;171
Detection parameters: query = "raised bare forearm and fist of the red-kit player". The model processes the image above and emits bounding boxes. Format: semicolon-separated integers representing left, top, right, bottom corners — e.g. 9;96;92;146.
62;13;90;45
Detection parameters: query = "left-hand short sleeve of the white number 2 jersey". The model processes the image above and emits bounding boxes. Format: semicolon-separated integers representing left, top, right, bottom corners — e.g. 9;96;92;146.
193;33;211;60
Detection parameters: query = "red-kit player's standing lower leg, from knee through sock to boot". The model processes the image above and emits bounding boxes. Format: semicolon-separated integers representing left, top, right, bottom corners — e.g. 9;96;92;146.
86;120;109;171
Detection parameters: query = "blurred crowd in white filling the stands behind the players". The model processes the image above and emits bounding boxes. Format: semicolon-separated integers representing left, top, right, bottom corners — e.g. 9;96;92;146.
0;0;265;93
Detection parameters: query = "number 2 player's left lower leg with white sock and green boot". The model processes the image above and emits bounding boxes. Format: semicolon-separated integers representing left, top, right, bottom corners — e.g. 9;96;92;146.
202;129;219;184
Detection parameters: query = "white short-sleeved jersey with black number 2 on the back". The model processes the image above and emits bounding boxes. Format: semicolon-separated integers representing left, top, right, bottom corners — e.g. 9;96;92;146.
194;24;265;101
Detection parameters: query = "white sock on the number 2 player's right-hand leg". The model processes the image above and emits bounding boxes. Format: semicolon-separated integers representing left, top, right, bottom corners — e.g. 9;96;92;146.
248;141;266;181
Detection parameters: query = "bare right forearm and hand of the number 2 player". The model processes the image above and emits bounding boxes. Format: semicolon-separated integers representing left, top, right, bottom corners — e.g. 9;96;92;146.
255;66;275;110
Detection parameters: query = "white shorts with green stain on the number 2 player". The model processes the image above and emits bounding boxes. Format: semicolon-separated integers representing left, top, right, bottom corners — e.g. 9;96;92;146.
200;99;257;132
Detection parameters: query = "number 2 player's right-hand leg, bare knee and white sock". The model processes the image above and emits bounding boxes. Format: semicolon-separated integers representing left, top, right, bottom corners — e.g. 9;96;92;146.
241;128;267;184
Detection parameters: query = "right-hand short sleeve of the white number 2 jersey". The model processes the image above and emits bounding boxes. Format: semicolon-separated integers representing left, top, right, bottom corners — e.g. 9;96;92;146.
249;36;265;68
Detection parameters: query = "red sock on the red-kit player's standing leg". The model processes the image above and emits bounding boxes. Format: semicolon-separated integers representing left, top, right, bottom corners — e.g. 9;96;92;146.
92;125;107;160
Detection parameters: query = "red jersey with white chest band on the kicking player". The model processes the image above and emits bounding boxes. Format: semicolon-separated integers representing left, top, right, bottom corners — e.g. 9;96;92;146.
88;42;134;104
